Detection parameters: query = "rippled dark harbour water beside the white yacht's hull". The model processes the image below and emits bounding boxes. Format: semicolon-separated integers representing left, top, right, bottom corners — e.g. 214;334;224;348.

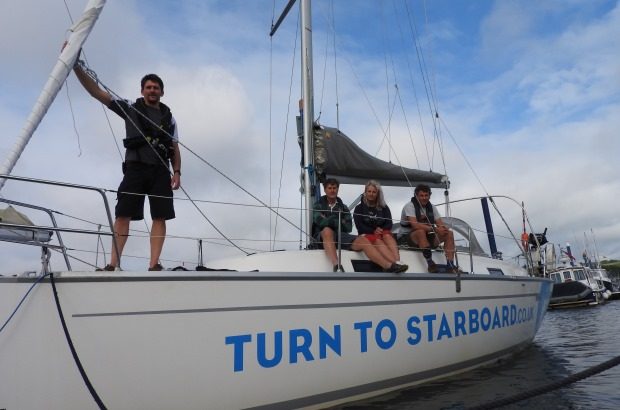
340;300;620;410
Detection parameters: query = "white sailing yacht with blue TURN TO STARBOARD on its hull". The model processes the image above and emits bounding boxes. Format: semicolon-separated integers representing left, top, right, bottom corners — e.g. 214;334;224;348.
0;0;552;410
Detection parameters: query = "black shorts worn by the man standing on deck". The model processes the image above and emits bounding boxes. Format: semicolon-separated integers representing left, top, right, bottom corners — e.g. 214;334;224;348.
115;161;175;221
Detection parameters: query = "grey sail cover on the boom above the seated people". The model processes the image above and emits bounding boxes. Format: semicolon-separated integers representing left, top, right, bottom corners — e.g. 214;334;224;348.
314;126;449;188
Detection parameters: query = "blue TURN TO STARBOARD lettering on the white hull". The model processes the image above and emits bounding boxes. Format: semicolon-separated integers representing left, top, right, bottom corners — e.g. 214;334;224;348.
225;304;535;372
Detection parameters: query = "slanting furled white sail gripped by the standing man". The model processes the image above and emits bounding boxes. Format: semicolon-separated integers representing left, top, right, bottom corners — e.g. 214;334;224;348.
0;0;105;191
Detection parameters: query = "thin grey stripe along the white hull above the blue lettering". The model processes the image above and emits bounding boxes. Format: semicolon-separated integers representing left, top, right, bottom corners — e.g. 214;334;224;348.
71;293;538;318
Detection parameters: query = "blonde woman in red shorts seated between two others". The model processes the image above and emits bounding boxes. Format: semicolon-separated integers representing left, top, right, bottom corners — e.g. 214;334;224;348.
353;180;408;273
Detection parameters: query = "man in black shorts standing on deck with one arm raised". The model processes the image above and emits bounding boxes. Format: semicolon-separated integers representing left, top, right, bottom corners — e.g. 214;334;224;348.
74;51;181;271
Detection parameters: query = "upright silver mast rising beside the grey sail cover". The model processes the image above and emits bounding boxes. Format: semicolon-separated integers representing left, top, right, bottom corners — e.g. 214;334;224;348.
300;0;315;245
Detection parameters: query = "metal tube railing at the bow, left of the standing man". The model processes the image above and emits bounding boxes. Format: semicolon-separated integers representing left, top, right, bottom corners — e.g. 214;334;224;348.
0;174;118;272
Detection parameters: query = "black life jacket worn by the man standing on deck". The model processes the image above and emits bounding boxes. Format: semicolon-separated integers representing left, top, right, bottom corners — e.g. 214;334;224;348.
123;97;174;160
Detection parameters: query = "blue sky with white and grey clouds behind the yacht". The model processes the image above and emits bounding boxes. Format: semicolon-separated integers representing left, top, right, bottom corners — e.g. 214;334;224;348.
0;0;620;274
